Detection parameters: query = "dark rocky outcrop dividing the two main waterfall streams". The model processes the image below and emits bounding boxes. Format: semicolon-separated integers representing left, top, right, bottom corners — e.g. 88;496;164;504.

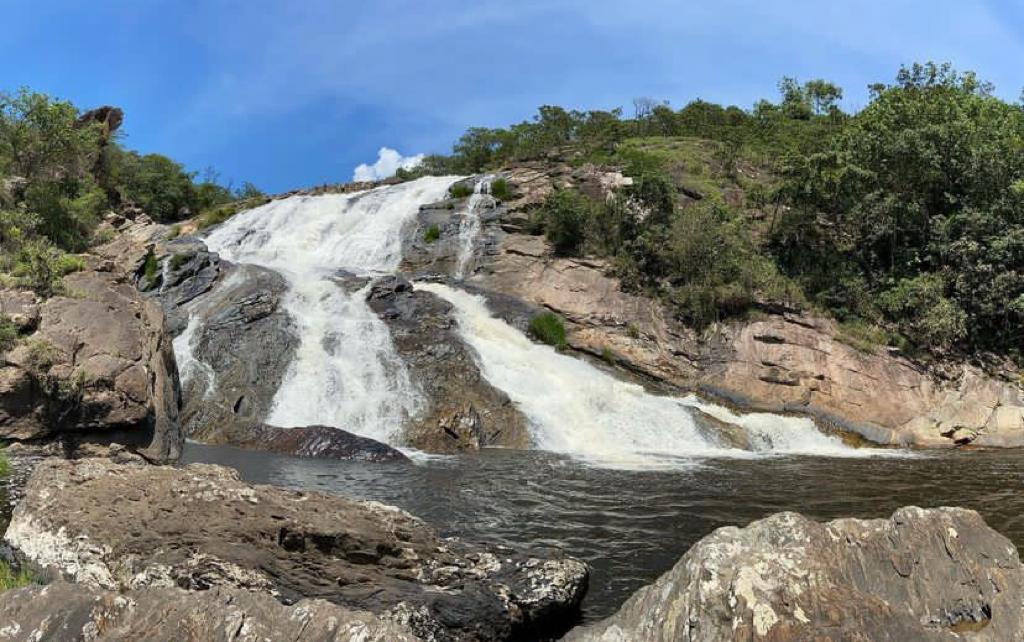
368;276;529;453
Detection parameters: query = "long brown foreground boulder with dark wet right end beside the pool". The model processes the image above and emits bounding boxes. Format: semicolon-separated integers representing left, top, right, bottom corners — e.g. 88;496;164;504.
5;459;588;642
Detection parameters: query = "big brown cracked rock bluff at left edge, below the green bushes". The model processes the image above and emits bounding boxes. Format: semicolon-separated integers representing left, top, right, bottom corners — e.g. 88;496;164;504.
0;264;182;461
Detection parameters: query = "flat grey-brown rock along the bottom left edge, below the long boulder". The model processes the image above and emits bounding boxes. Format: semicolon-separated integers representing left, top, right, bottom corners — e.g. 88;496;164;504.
0;582;418;642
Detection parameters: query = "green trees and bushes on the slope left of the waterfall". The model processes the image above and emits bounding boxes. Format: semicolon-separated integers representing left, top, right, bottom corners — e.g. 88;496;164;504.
0;89;262;296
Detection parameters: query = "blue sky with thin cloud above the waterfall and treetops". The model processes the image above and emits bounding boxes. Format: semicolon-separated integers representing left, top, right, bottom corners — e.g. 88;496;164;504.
6;0;1024;191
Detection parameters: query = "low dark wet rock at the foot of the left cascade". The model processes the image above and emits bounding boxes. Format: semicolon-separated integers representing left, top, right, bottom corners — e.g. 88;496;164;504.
233;424;409;462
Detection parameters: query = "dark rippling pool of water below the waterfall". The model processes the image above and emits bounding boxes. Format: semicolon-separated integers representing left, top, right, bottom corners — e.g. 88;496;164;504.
183;444;1024;619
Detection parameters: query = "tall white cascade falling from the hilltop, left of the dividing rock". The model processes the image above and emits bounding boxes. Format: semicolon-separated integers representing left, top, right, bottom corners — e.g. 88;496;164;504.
207;177;455;441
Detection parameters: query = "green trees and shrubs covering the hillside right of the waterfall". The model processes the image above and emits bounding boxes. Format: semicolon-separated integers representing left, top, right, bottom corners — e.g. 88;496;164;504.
417;63;1024;361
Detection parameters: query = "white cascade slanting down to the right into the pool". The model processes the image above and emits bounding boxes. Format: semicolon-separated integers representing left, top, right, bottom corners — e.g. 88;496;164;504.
417;284;897;468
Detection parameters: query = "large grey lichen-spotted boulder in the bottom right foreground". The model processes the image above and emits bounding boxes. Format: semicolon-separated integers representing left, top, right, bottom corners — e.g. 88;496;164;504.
565;508;1024;642
